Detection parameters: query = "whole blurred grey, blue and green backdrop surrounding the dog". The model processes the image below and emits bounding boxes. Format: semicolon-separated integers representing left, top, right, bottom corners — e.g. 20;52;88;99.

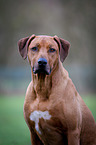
0;0;96;145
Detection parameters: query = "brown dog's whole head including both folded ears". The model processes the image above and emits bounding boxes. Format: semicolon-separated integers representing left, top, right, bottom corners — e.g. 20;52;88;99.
18;35;70;75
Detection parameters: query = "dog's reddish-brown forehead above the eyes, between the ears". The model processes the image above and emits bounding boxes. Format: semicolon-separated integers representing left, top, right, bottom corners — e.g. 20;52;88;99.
29;35;58;48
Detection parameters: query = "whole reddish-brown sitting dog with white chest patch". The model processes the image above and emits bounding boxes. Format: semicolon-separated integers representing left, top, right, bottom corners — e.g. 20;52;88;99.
18;35;96;145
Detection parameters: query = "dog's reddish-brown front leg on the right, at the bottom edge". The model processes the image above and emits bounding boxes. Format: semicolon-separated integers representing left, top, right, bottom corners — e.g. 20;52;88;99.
68;129;80;145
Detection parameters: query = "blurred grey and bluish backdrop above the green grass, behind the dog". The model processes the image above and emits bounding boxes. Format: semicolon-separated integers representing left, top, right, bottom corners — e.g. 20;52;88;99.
0;0;96;94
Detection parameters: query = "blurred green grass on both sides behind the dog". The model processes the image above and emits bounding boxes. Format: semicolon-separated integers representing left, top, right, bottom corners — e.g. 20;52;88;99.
0;96;96;145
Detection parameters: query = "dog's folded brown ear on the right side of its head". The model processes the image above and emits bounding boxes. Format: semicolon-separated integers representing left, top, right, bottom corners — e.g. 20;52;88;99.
53;36;70;62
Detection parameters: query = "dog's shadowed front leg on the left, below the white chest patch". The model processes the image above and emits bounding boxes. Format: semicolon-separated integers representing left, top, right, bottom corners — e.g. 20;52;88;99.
30;130;44;145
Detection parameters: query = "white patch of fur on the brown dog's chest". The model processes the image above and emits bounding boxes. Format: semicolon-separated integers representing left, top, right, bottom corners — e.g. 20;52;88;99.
30;111;51;134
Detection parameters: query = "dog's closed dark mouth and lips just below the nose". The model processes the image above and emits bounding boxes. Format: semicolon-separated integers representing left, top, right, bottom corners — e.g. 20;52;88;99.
32;67;51;75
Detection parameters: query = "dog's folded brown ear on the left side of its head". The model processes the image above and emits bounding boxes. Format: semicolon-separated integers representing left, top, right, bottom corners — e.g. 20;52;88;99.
18;34;35;59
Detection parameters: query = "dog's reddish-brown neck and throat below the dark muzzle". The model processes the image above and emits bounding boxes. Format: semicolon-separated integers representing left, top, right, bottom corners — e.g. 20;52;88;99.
31;64;67;100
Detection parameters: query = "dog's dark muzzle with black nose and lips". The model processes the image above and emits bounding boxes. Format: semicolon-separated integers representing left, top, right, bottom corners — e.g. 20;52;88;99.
33;58;51;75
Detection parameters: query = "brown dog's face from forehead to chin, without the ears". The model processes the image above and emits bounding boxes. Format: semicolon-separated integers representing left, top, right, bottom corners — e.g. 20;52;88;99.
28;36;59;75
